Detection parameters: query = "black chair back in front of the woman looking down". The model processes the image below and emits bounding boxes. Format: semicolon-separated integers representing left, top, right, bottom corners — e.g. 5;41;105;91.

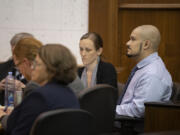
79;84;117;134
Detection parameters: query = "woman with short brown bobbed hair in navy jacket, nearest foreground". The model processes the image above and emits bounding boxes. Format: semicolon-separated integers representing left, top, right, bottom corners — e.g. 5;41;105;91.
3;44;79;135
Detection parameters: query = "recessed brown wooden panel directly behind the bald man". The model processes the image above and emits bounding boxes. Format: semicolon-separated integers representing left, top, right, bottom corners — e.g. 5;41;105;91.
117;9;180;82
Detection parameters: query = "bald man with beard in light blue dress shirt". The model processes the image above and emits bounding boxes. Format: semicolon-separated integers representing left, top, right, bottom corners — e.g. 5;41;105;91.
116;25;172;117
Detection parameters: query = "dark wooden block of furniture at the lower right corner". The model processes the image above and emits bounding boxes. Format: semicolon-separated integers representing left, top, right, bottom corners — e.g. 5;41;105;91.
144;102;180;133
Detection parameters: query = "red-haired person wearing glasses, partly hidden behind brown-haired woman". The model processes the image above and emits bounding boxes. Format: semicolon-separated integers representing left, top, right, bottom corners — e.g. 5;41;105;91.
0;37;42;129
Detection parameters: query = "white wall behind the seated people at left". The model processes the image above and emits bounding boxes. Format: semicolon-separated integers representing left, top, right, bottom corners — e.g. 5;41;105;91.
0;0;88;64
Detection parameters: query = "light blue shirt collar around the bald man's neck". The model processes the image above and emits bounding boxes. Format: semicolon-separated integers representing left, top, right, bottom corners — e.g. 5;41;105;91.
137;52;159;69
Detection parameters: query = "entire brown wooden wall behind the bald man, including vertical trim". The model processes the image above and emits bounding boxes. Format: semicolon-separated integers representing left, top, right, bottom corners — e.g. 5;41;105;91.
89;0;180;83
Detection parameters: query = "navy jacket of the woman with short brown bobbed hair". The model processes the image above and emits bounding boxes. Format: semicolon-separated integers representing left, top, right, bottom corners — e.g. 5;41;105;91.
6;82;79;135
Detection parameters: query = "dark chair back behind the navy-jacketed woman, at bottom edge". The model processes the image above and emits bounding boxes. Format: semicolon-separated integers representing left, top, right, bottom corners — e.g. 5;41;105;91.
30;109;94;135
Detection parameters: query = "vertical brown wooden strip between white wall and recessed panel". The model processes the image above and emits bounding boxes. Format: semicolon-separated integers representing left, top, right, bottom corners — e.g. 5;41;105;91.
89;0;118;63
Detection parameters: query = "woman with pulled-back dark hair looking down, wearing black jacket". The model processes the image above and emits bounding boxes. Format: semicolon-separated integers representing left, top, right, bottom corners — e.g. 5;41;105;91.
78;32;117;88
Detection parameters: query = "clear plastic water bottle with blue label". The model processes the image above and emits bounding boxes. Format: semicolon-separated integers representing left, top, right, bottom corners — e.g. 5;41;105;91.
5;72;15;107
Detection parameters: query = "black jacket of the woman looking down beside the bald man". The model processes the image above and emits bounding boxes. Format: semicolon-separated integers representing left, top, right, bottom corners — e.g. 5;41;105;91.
78;60;117;88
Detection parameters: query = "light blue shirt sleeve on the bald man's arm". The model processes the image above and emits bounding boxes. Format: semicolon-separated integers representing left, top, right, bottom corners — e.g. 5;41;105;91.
116;74;171;117
